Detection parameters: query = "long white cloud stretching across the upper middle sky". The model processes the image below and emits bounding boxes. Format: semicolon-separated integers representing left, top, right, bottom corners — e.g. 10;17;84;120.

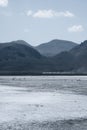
27;9;74;18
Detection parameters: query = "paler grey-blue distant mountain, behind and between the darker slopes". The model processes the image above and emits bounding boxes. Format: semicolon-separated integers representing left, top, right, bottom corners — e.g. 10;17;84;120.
35;39;77;56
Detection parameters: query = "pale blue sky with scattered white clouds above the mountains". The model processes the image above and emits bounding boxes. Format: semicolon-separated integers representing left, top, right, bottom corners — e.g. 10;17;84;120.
0;0;87;46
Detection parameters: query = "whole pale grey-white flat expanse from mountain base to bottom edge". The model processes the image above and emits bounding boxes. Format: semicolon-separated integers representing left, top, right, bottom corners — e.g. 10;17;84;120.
0;76;87;130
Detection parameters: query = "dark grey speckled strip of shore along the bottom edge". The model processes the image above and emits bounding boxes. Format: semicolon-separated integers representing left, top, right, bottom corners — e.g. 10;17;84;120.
0;119;87;130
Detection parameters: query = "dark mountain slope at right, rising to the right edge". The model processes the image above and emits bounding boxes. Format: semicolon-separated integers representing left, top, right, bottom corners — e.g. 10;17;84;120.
52;41;87;73
